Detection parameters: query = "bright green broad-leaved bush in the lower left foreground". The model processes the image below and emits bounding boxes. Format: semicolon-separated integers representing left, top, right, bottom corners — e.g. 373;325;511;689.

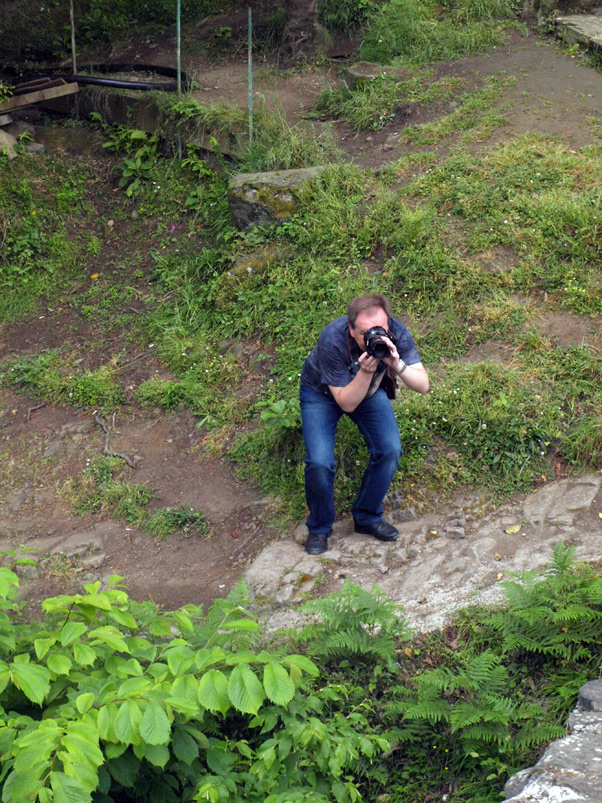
0;568;388;803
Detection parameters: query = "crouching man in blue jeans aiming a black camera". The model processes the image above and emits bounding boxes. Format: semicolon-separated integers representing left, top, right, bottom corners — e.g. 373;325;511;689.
299;295;429;555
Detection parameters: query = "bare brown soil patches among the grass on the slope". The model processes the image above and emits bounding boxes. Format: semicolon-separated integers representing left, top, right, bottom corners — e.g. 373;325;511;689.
0;28;602;609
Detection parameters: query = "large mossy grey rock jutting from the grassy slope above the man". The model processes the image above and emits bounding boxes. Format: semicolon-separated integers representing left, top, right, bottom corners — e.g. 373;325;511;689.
228;167;324;229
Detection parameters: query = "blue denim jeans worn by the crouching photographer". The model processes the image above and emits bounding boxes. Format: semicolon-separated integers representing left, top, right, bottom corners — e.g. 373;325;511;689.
299;384;401;535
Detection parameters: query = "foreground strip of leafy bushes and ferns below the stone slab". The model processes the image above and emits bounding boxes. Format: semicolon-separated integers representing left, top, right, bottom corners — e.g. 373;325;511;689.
0;545;602;803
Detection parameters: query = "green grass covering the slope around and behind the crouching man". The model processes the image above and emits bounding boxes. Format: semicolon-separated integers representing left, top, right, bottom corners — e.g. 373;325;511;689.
0;100;602;519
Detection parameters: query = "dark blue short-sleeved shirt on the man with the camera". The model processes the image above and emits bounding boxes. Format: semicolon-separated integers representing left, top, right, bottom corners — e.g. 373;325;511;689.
301;315;420;395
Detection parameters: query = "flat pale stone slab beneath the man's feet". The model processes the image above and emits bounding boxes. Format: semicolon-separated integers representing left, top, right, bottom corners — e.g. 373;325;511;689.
245;473;602;636
